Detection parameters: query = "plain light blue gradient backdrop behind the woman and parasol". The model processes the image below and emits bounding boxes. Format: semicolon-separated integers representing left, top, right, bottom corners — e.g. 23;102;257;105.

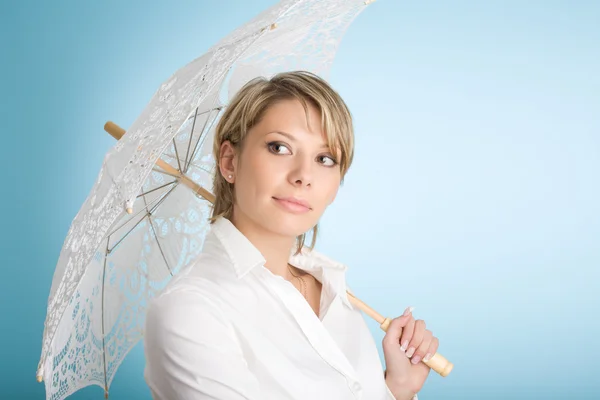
0;0;600;400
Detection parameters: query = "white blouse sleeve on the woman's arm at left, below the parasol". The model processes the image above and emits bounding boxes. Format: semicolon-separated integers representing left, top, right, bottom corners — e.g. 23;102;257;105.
144;290;264;400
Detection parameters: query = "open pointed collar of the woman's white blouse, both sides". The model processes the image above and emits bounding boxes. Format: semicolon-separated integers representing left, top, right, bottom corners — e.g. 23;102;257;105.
210;217;352;308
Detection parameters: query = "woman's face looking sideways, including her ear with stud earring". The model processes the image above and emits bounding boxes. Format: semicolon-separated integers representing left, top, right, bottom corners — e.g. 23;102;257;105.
221;100;341;237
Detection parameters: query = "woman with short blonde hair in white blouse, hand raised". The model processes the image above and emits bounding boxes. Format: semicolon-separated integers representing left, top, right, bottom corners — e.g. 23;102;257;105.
144;72;438;400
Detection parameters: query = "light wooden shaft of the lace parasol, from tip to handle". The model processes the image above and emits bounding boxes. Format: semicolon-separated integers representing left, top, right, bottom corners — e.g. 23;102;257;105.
104;121;454;376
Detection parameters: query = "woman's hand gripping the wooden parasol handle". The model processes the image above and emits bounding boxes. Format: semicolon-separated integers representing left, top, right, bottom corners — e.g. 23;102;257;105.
383;307;439;400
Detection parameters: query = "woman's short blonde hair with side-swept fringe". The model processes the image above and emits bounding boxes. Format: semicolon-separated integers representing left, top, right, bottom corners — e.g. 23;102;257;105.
210;71;354;254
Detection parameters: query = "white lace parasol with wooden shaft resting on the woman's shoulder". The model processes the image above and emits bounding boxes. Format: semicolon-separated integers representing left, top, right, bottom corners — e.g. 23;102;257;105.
37;0;452;400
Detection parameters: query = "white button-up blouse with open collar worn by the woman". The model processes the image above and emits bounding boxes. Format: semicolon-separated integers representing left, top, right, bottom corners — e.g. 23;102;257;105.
144;217;416;400
